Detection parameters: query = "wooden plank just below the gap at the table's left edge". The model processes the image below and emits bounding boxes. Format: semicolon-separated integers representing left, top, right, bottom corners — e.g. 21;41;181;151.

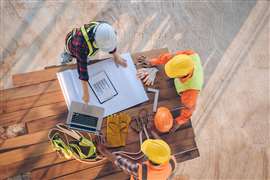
0;130;49;152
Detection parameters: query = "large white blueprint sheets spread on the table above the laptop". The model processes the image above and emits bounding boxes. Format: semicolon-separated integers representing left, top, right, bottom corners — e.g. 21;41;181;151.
57;53;148;117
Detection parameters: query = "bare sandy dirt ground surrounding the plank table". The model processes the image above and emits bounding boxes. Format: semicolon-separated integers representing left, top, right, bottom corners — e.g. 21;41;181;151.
0;0;270;179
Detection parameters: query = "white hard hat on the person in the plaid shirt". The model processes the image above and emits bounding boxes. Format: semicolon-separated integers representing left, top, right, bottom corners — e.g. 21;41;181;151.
95;23;117;52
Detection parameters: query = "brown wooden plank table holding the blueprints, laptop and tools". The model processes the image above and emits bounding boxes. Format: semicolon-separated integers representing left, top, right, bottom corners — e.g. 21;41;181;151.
0;49;199;179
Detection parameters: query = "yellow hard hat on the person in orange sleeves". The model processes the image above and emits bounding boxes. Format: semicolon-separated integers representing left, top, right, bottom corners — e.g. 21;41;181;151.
165;54;194;78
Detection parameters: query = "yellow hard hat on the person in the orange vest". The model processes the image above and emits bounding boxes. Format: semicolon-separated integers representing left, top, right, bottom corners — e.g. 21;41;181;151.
141;139;171;164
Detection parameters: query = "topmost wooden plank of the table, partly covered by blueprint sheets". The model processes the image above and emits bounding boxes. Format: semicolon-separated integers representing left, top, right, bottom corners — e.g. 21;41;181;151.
12;48;168;87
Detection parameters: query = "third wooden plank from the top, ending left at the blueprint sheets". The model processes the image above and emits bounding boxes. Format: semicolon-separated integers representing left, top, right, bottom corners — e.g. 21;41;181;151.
2;91;64;113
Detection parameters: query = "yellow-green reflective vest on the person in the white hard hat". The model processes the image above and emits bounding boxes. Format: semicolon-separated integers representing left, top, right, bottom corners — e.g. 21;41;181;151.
81;22;98;57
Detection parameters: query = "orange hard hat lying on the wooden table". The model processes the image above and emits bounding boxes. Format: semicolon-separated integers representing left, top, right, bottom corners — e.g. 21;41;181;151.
154;107;173;133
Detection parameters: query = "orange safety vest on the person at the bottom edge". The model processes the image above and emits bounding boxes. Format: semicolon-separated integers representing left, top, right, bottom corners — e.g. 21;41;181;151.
130;156;177;180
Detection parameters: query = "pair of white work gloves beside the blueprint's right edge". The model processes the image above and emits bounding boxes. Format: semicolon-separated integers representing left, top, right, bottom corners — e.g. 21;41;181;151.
137;67;158;86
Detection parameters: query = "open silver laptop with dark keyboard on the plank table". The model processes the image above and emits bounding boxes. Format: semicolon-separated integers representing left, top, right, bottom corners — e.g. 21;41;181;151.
67;101;104;135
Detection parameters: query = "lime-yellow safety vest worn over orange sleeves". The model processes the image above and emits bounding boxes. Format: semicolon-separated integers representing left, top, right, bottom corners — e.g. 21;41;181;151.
174;54;203;94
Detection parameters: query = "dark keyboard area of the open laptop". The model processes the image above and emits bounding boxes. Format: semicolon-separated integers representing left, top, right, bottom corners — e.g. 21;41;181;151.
71;112;98;128
